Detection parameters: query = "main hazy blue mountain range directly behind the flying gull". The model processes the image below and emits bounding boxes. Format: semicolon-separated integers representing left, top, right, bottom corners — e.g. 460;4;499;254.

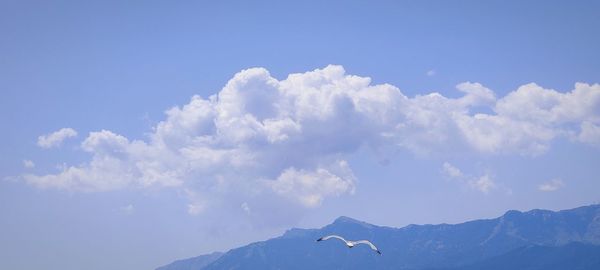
158;205;600;270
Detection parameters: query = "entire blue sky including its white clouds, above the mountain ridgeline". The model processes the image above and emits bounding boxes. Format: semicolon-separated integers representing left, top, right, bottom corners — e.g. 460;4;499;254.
0;0;600;269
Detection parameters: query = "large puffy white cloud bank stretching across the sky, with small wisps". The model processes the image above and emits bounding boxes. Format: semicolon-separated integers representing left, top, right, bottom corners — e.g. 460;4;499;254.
22;66;600;209
